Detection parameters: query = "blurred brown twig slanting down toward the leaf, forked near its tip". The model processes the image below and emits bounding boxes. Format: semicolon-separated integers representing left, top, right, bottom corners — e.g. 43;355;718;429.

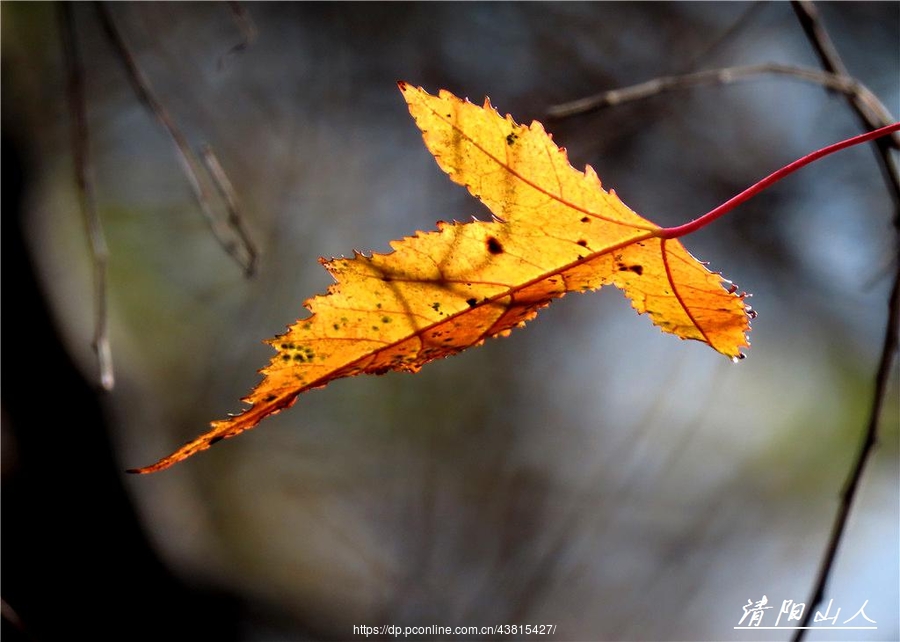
98;2;257;276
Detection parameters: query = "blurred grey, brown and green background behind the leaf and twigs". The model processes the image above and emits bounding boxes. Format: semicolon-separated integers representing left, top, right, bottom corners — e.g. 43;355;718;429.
2;2;900;641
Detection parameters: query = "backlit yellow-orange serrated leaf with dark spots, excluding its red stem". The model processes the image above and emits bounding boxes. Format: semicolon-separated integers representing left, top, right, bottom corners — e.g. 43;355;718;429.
132;83;749;473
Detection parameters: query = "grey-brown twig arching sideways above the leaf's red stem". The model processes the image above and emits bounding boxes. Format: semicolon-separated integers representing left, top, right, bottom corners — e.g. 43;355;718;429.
547;63;900;140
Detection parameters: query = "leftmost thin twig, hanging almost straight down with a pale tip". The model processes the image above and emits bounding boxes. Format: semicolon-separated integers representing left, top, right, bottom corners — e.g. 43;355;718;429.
60;3;116;391
